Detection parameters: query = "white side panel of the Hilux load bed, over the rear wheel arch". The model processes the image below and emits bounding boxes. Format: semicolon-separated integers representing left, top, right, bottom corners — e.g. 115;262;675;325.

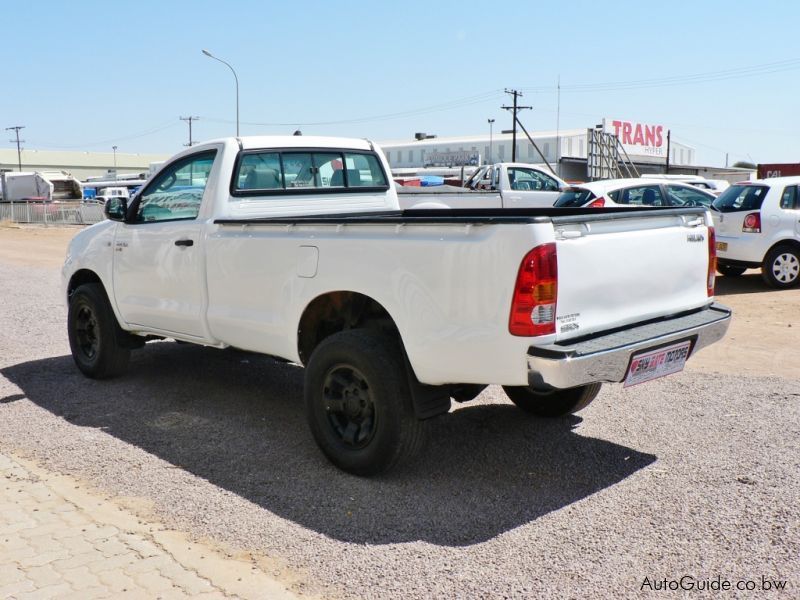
207;223;552;385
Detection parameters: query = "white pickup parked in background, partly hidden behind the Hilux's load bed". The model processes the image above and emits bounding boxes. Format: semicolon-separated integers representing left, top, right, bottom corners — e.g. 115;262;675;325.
397;163;568;210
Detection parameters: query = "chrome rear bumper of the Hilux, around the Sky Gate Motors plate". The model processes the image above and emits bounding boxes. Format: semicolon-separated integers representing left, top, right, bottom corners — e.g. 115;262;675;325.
528;303;731;388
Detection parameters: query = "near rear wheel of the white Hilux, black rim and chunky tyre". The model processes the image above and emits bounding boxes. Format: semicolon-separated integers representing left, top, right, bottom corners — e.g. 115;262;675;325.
305;329;425;475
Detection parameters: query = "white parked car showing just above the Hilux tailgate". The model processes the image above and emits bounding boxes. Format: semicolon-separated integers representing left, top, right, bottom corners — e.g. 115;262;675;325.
554;179;715;208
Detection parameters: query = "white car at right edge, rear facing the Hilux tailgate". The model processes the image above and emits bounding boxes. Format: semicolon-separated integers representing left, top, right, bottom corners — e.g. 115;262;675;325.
712;177;800;288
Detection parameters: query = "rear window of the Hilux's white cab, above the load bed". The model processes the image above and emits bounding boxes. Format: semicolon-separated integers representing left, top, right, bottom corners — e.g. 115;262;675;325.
231;149;389;196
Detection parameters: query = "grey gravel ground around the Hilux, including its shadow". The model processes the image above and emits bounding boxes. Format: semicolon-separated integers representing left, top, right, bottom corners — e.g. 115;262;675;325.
0;263;800;598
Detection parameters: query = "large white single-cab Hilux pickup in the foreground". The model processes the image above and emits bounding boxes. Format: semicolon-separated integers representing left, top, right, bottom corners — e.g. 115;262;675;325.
63;136;730;475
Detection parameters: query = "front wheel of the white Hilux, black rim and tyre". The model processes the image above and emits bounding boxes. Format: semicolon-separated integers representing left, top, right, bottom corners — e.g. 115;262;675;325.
67;283;131;379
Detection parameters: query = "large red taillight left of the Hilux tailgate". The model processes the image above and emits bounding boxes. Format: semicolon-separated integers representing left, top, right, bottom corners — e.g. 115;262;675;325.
508;243;558;337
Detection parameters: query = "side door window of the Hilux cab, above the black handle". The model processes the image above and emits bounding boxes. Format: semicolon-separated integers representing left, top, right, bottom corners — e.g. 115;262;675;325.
136;150;217;223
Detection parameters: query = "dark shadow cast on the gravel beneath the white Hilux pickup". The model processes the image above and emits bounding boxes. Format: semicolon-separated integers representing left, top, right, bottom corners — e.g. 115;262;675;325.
2;342;655;546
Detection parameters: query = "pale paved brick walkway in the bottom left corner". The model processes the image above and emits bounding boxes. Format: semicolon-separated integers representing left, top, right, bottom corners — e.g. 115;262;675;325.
0;453;293;600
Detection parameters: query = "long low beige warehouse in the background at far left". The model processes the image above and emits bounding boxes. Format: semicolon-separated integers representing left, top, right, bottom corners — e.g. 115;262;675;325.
0;148;170;181
